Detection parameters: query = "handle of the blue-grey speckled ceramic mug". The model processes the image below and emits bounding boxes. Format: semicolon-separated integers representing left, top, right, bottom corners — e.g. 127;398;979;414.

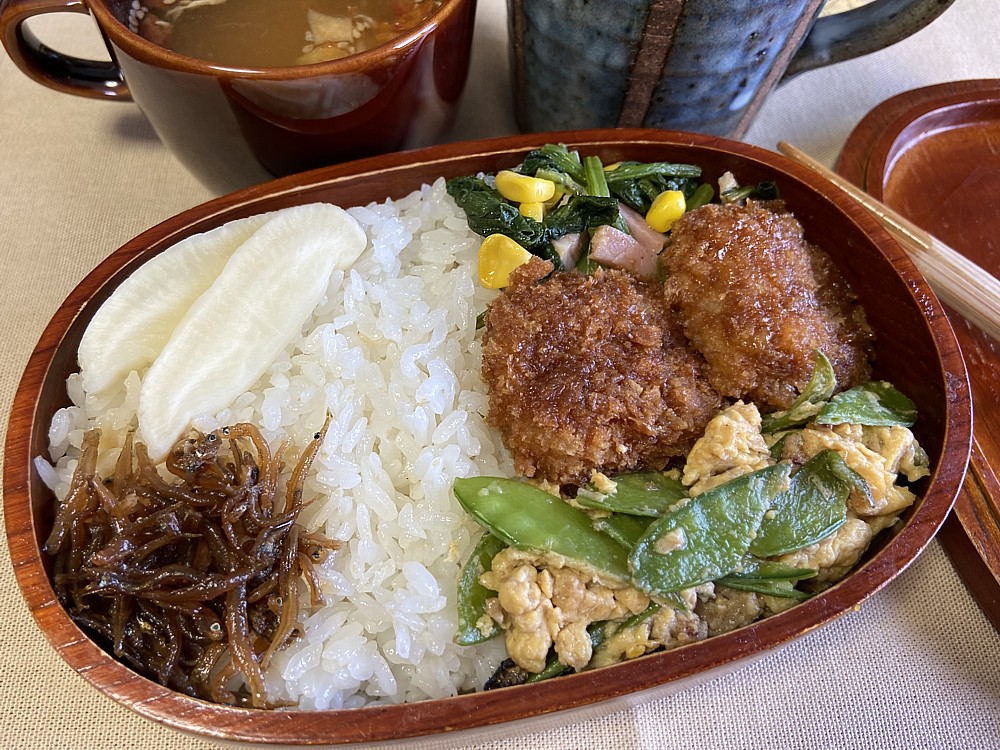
782;0;955;81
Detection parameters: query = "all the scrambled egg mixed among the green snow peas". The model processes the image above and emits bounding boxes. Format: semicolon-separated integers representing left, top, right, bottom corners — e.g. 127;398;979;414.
481;402;929;672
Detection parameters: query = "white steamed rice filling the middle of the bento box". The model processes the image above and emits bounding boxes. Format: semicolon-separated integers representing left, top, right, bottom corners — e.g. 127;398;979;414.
36;180;512;709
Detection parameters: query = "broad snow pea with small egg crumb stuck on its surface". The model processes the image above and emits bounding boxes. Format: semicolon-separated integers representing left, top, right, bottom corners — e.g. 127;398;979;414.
629;463;791;596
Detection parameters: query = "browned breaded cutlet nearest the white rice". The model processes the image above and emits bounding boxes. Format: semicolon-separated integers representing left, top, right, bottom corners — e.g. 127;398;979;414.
483;260;720;484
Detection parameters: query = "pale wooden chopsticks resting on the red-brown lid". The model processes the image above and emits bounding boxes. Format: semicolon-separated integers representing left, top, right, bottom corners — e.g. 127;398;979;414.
778;141;1000;341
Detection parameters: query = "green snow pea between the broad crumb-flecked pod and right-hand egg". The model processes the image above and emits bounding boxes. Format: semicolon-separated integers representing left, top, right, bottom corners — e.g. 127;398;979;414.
750;450;868;557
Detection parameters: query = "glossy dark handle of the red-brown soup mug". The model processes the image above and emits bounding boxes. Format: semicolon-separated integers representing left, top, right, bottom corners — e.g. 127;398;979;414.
0;0;132;100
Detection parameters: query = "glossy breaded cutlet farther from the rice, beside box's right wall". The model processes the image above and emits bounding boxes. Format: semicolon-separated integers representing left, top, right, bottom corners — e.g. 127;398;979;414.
660;202;872;409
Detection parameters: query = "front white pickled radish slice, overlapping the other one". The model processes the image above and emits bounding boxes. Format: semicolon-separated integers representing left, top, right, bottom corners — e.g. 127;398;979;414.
138;203;367;461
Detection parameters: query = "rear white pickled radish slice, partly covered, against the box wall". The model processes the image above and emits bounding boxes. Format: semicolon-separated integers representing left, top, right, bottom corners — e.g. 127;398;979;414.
77;214;270;399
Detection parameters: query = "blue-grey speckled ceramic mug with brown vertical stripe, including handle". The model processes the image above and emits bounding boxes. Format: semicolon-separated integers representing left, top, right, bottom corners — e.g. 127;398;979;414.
508;0;953;138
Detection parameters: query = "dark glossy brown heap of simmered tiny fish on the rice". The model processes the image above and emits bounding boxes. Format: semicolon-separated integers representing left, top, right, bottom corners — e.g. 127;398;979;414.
45;424;339;708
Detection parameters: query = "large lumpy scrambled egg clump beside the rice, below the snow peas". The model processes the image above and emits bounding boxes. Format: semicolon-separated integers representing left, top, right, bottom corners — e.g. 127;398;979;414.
480;548;649;672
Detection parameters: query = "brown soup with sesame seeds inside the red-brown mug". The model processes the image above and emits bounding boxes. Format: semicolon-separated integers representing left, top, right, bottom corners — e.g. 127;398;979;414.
128;0;441;68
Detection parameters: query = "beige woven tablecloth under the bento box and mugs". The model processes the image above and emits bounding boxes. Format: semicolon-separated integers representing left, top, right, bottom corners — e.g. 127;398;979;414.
0;0;1000;750
